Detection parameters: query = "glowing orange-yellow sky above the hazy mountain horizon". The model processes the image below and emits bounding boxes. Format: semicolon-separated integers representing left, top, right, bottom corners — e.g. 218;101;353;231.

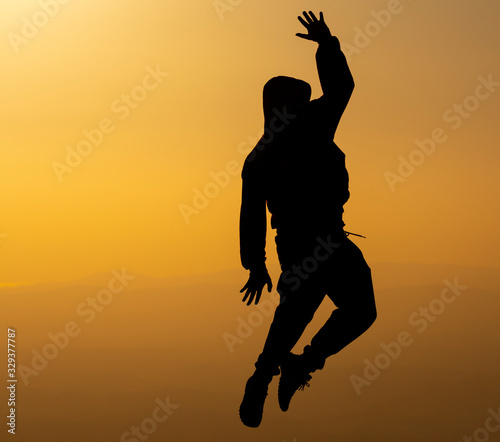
0;0;500;284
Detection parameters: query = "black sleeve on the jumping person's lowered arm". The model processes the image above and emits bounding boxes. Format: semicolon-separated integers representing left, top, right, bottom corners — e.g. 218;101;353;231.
240;163;267;272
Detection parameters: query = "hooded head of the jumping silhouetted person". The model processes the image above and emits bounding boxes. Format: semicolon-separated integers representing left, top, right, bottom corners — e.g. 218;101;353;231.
262;76;311;126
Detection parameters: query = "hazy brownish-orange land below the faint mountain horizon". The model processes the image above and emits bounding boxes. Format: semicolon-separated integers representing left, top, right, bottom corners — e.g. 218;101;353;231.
0;266;500;442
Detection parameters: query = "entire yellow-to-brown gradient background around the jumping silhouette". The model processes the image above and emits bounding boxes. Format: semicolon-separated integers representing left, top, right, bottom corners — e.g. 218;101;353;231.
0;0;500;442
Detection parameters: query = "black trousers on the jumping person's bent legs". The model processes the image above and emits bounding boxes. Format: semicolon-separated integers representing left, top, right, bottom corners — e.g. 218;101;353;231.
255;233;377;375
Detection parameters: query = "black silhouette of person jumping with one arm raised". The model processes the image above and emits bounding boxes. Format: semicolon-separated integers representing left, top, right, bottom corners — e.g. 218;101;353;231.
240;12;376;427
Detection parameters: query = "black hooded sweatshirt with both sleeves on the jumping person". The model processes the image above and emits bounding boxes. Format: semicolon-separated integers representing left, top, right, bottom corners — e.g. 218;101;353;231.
240;37;354;271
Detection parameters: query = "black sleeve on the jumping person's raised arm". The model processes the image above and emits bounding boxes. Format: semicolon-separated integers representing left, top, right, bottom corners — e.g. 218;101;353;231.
314;37;354;138
